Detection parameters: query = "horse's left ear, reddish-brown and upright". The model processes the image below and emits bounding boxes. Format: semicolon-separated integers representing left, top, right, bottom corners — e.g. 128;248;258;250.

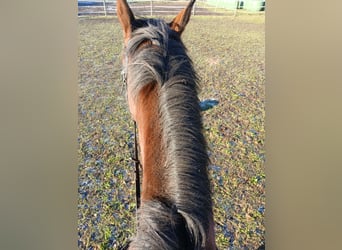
116;0;135;42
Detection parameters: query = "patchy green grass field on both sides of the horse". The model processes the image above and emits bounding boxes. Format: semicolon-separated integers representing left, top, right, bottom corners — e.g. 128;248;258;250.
78;15;265;249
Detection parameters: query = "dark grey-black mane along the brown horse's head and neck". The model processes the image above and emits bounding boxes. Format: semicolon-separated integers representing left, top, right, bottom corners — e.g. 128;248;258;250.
125;19;212;249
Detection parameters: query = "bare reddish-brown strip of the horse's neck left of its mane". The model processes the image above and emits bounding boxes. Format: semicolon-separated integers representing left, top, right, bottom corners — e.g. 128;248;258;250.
136;83;165;201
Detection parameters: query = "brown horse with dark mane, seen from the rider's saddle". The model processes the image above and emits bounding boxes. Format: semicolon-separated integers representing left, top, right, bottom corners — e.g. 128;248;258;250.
117;0;216;250
